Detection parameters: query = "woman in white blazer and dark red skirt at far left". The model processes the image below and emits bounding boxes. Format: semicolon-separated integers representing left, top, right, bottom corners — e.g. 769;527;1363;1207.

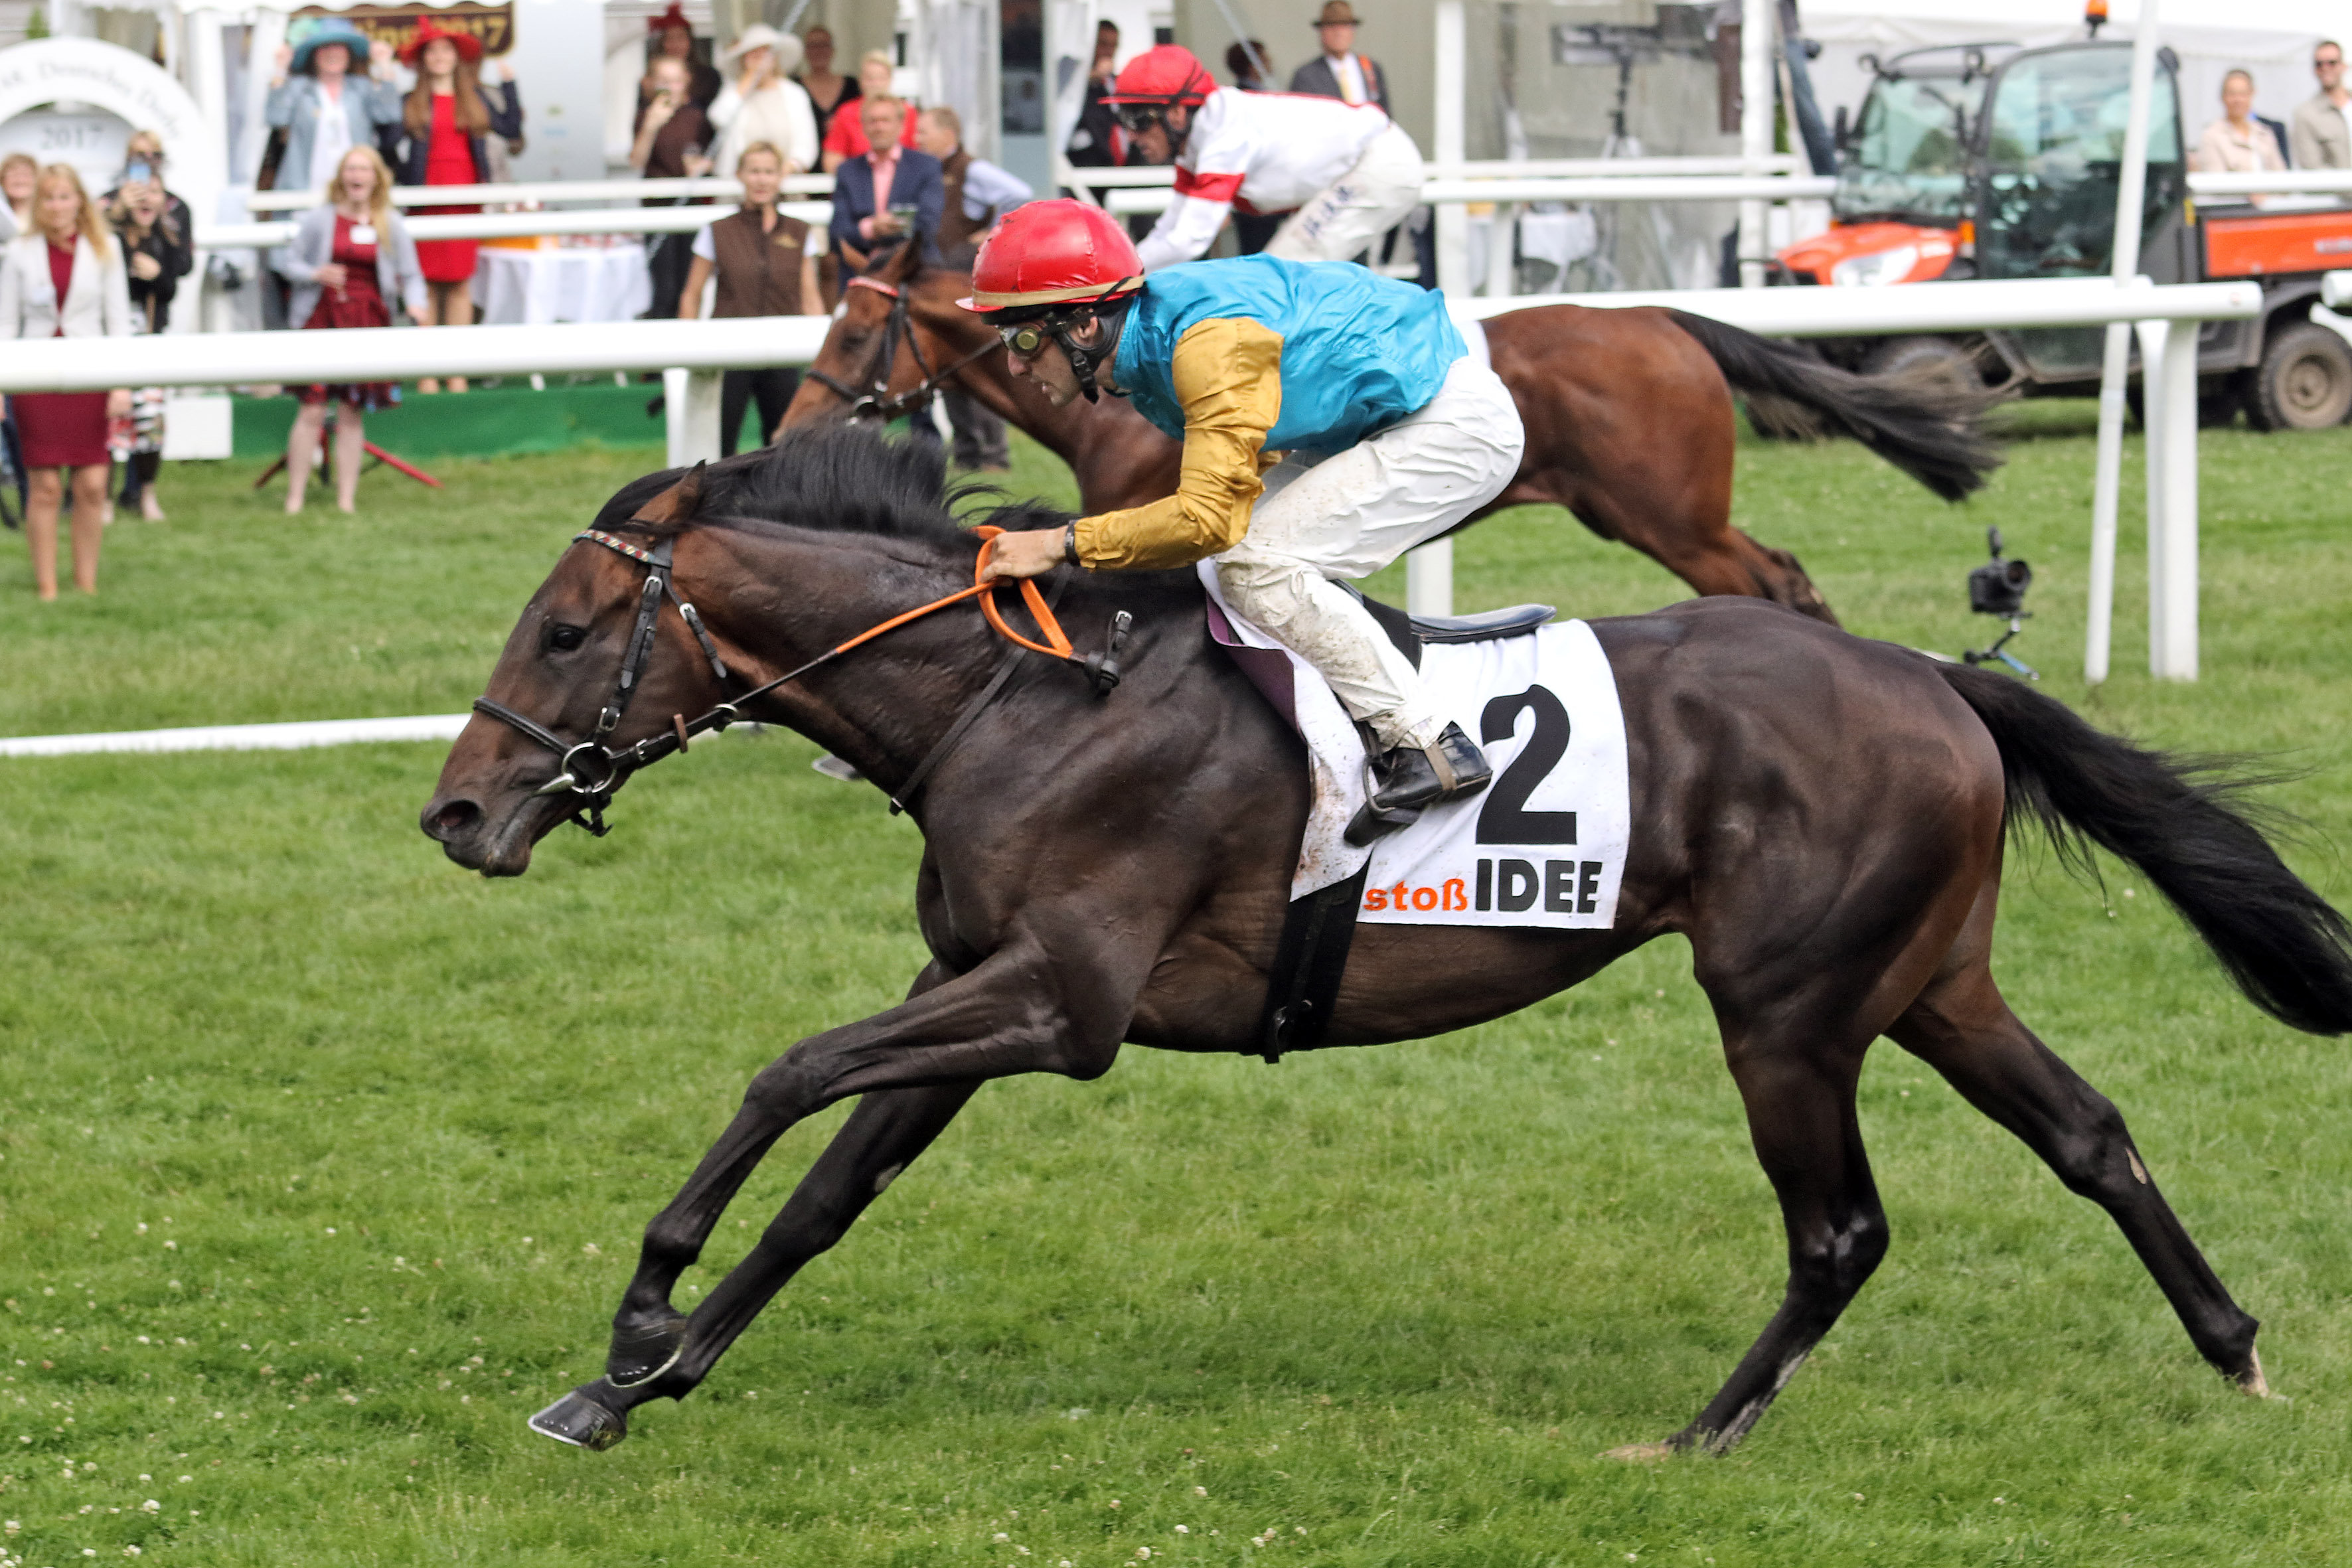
0;162;131;599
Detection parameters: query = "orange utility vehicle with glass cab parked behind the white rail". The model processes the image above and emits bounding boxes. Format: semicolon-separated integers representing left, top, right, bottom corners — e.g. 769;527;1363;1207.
1773;40;2352;430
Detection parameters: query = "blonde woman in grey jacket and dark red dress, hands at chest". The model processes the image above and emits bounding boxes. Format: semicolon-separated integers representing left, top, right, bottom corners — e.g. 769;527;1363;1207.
285;148;426;512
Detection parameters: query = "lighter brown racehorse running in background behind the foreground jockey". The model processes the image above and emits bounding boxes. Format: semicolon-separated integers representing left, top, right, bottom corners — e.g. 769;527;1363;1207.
783;247;2001;625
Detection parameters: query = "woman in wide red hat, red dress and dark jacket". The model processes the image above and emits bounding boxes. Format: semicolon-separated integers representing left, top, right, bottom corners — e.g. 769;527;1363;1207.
400;17;522;392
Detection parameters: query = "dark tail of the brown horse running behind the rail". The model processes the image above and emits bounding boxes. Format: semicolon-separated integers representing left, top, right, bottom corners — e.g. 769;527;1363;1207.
1668;310;2001;501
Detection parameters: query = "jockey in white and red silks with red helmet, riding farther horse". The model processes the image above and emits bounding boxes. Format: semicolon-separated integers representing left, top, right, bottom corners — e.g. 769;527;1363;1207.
1103;44;1421;273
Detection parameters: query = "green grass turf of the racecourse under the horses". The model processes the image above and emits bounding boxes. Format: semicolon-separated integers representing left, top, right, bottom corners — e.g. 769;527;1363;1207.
0;404;2352;1568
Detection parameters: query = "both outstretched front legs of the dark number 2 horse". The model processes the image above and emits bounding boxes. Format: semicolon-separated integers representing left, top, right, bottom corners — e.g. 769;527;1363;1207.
532;943;1140;1448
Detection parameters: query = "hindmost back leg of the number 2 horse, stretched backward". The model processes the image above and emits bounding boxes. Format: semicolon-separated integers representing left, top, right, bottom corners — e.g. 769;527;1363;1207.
1889;949;2270;1394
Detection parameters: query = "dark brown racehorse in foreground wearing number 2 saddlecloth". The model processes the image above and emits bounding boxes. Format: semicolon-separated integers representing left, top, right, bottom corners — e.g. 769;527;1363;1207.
424;428;2352;1452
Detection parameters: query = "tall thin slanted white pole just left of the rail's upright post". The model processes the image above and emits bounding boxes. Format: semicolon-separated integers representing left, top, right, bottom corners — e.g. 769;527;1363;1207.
2082;0;2163;686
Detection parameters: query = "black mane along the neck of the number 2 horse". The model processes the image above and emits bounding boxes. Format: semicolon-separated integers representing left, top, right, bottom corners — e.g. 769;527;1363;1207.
595;423;1068;546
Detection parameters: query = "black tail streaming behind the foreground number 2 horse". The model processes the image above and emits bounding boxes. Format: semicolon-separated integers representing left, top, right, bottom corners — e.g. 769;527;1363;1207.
1936;665;2352;1034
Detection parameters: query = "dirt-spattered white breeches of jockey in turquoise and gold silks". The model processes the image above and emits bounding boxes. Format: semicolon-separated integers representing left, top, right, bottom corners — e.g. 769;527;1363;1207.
1216;357;1526;747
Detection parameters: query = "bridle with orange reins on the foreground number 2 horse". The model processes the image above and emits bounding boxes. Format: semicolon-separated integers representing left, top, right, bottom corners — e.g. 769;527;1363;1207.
473;503;1134;839
